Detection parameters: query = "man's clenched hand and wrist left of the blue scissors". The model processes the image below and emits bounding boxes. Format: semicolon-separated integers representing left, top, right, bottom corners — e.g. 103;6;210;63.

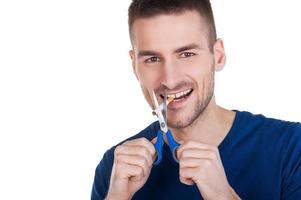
106;138;156;200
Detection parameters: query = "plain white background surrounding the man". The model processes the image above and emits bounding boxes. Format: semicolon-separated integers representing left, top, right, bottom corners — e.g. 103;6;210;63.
0;0;301;200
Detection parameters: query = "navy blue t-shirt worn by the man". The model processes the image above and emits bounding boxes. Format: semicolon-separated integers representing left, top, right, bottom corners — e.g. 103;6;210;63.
91;111;301;200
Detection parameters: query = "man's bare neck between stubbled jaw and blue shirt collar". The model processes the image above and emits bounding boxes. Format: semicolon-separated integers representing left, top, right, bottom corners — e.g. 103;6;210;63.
170;96;235;146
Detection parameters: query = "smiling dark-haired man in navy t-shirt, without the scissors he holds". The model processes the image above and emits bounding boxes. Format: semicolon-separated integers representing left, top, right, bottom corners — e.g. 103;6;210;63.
92;0;301;200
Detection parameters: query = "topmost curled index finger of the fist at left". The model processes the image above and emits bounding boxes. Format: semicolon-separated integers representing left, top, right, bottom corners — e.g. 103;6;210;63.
115;145;153;166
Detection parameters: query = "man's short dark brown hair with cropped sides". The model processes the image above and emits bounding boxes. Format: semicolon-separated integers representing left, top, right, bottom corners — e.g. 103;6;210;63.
128;0;217;48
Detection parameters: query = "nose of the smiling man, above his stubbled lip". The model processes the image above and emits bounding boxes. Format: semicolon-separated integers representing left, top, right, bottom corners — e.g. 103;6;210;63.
161;60;180;90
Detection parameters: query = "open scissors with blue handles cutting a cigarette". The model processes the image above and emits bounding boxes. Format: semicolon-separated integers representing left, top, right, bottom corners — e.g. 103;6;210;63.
153;91;180;165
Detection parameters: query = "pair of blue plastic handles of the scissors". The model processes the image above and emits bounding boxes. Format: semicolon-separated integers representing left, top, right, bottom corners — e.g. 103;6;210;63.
154;130;180;165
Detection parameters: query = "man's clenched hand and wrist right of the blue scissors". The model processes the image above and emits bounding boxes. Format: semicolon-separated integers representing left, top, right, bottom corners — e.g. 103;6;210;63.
177;141;239;199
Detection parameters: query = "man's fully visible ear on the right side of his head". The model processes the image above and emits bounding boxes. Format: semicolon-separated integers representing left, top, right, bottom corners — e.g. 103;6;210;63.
213;39;226;71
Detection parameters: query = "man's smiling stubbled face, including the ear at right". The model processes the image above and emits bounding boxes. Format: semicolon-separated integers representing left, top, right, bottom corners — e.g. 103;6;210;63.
130;11;224;129
